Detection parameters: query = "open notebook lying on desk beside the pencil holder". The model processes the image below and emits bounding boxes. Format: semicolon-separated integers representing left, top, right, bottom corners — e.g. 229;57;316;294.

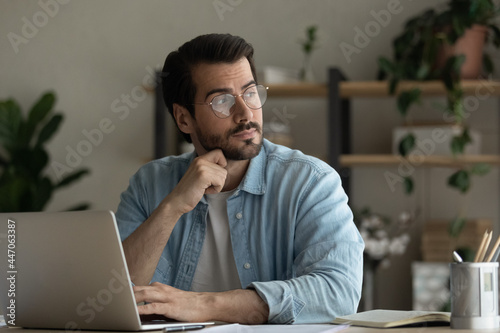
333;310;450;327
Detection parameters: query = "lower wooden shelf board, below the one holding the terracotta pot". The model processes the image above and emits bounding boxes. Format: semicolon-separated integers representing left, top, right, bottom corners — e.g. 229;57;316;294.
340;154;500;167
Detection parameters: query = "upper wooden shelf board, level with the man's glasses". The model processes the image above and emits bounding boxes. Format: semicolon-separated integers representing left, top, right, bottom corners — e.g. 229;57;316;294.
268;80;500;99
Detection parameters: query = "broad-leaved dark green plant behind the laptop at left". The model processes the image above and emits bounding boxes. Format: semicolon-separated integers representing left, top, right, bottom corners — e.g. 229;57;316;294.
0;92;89;212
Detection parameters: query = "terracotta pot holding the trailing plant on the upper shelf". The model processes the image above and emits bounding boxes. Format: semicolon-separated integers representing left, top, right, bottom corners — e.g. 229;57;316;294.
436;25;488;79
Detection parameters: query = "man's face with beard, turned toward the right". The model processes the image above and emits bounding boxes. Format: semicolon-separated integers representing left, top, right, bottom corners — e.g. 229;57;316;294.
191;58;262;160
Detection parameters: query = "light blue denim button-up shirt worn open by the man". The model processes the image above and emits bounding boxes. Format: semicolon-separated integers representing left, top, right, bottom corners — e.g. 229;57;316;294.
116;140;364;324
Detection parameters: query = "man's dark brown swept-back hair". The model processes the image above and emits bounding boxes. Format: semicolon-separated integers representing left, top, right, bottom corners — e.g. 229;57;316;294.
162;34;257;142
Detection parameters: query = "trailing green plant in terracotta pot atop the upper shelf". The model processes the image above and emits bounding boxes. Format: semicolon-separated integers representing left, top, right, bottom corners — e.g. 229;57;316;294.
378;0;500;240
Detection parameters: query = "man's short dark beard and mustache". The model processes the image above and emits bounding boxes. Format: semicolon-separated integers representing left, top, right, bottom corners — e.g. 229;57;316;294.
196;122;263;161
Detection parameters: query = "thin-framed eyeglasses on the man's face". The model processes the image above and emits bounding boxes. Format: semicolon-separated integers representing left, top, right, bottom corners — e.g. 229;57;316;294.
193;84;269;118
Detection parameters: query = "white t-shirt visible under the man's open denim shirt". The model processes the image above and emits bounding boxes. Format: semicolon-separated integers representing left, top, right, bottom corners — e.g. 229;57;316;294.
191;191;241;292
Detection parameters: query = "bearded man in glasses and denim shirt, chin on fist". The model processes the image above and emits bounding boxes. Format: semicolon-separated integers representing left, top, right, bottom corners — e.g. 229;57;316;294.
116;34;363;324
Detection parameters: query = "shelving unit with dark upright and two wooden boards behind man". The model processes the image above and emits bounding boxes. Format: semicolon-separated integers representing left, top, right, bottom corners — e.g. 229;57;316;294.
269;68;500;193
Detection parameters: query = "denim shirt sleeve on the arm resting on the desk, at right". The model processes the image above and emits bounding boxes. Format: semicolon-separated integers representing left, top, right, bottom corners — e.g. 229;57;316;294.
249;171;364;324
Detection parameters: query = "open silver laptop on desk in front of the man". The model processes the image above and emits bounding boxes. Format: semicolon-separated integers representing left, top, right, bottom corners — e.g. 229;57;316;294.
0;211;213;331
